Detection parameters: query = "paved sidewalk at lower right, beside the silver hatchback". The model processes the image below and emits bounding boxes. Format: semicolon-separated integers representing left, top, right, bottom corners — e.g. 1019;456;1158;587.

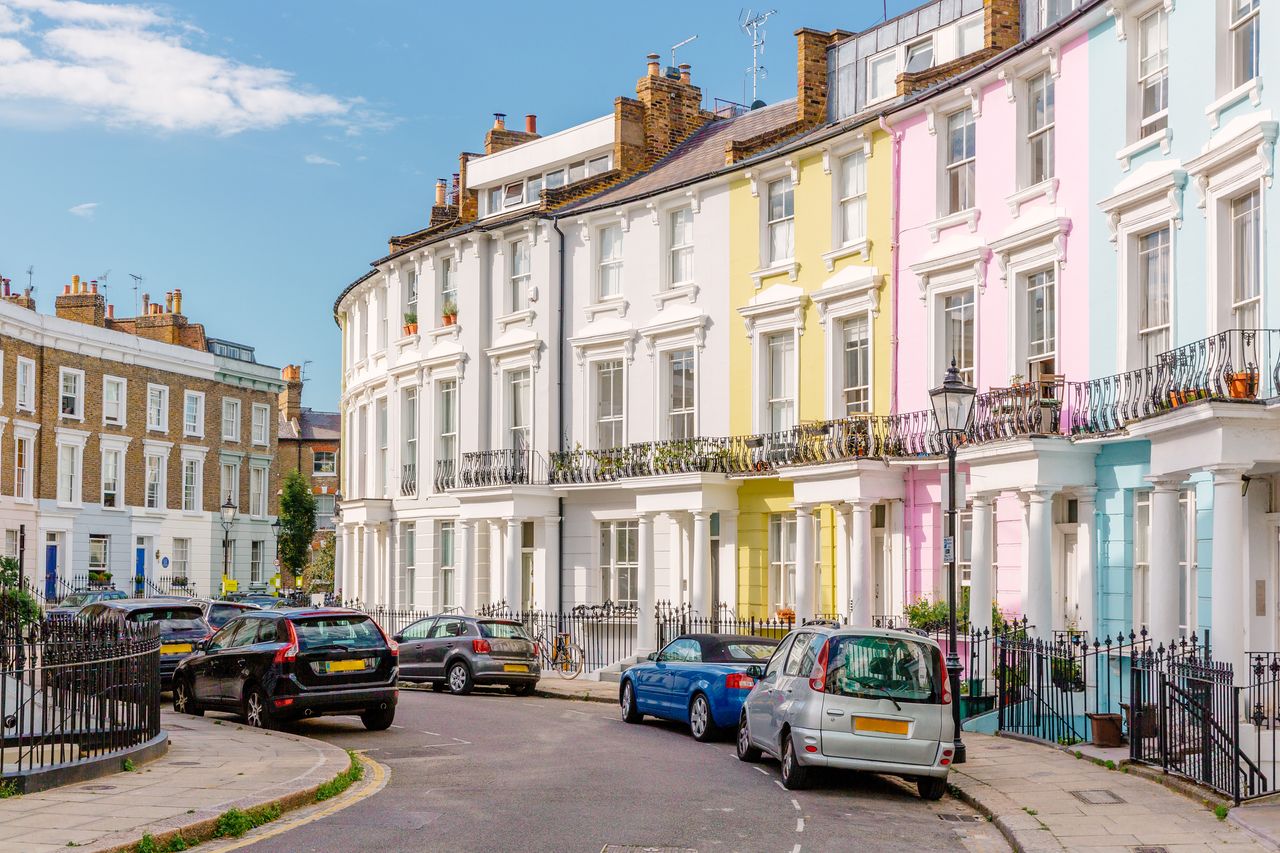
951;733;1272;853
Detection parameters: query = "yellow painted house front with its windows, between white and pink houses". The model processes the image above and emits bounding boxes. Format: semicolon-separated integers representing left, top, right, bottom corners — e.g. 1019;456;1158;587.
730;124;892;617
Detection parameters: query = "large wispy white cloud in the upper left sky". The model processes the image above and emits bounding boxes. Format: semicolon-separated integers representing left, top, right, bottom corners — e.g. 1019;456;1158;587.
0;0;360;134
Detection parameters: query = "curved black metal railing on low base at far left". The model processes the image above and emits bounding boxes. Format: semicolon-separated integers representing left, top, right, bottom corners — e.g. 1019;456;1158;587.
0;601;160;789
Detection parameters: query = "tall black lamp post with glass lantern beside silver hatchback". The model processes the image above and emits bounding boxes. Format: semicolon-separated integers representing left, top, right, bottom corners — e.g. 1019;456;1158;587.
929;359;989;765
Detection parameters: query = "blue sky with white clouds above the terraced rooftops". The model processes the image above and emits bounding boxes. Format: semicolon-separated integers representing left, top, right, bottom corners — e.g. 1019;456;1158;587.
0;0;916;409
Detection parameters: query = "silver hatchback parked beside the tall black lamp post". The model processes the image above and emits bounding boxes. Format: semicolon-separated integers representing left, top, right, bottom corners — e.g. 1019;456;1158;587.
737;624;955;799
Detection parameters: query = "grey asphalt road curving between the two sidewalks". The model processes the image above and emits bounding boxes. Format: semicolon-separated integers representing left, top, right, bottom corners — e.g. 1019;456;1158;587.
225;690;1009;853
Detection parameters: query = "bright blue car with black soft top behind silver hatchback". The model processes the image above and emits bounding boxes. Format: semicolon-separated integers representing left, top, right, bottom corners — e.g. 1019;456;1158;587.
618;634;778;742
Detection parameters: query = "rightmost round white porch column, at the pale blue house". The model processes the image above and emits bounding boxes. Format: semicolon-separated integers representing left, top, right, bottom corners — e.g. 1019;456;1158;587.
1210;467;1248;684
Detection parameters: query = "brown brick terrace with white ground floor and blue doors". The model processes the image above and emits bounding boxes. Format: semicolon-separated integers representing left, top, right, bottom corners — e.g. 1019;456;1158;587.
0;277;283;597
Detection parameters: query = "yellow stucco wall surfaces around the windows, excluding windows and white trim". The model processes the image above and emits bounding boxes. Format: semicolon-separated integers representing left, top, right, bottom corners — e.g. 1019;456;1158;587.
727;124;892;616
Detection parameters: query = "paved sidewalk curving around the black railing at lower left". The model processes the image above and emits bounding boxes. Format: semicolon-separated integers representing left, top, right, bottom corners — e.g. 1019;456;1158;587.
0;711;349;853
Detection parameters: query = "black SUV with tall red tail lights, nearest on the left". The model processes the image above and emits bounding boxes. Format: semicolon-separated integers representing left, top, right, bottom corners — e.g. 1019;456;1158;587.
173;608;399;730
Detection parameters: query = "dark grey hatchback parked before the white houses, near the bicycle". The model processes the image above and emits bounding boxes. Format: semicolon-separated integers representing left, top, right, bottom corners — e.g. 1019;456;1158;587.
394;616;541;695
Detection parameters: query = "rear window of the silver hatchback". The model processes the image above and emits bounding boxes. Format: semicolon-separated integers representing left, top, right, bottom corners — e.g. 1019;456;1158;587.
827;637;943;704
